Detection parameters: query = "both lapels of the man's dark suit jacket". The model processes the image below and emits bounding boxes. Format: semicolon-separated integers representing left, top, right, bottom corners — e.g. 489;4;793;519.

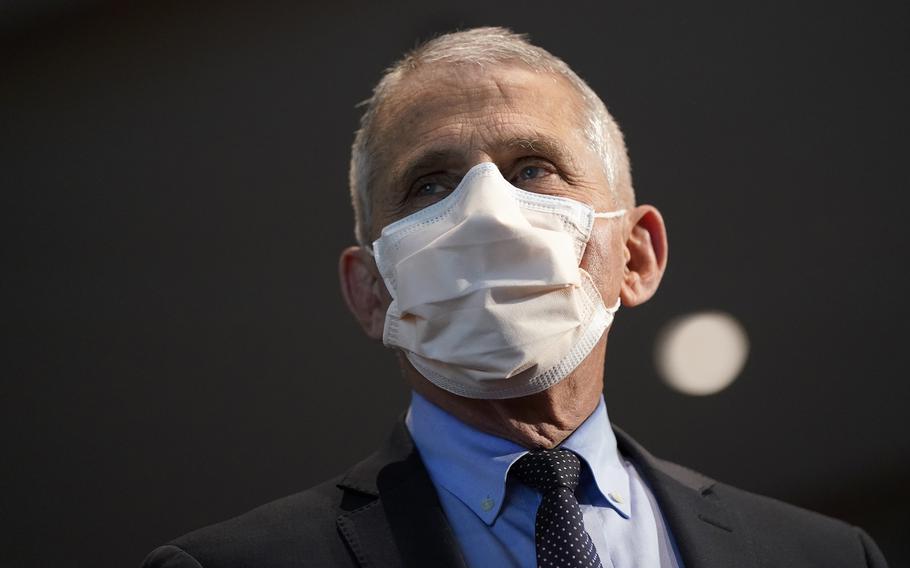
337;419;756;568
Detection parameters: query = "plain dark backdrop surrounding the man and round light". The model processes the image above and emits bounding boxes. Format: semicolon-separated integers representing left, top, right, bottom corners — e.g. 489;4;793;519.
0;0;910;566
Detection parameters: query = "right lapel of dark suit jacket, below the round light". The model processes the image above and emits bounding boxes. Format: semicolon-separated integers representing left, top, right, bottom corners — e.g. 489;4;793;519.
613;426;756;568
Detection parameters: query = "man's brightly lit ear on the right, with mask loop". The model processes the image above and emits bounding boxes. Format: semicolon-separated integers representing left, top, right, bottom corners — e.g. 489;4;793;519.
620;205;667;307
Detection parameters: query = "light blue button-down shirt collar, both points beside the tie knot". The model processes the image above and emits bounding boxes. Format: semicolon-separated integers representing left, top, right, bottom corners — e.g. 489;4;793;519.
405;392;630;525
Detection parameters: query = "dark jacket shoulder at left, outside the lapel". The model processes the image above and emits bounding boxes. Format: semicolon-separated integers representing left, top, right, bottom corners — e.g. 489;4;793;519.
143;478;364;568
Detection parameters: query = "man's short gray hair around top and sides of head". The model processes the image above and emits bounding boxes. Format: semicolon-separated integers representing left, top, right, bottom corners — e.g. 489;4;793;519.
350;27;634;246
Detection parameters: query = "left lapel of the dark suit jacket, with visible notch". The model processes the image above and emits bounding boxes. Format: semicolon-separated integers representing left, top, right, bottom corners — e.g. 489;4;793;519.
337;421;465;568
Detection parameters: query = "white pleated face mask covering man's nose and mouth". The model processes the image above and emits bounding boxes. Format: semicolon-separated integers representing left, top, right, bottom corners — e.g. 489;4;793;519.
373;162;625;399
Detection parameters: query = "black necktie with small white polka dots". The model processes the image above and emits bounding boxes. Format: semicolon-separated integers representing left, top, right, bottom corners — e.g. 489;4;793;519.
511;450;602;568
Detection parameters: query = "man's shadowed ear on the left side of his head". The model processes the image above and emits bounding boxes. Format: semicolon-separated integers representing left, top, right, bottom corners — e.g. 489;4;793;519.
338;246;389;339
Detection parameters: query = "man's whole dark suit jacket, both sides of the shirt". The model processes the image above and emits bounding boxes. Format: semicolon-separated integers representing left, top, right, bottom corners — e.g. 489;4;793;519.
143;421;887;568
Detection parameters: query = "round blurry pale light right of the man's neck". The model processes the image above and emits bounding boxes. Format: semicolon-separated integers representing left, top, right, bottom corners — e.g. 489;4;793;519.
655;312;749;396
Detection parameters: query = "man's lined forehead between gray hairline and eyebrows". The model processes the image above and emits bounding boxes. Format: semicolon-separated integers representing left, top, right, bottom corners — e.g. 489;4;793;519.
376;64;582;179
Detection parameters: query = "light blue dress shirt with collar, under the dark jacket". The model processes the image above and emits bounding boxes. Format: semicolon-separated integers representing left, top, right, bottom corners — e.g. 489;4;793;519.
406;393;682;568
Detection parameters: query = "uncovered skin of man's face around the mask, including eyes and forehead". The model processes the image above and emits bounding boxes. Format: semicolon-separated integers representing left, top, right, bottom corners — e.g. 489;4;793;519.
371;65;624;305
